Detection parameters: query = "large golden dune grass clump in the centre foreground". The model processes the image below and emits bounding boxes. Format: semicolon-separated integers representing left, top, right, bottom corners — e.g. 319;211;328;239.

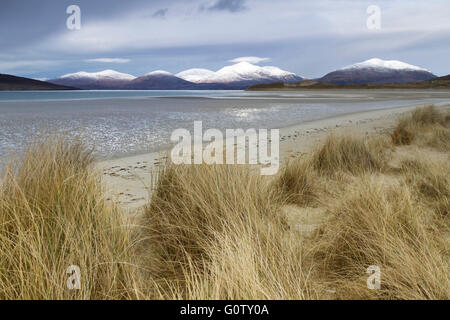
142;165;315;299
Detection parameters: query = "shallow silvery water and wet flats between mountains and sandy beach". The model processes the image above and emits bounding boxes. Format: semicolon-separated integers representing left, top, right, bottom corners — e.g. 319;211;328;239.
0;90;450;159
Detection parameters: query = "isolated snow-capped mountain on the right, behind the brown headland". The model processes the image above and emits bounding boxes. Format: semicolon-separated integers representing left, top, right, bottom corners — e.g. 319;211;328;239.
319;58;436;84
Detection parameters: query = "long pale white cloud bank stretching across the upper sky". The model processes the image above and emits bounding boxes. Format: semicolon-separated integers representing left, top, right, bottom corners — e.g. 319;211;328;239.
40;0;450;55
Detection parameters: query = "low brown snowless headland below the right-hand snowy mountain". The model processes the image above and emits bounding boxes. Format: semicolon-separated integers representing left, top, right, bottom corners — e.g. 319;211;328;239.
247;75;450;91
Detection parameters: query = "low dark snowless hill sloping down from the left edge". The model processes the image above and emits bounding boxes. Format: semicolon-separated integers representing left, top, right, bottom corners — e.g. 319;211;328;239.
0;74;77;91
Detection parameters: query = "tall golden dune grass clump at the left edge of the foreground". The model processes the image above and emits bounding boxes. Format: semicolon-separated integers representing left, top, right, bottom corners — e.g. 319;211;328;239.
0;137;136;299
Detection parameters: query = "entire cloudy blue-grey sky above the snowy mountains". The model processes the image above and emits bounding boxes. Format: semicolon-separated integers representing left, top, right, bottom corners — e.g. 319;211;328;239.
0;0;450;79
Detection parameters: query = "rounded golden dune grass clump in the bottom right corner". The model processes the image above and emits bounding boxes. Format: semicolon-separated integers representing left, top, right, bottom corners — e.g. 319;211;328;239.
317;177;450;299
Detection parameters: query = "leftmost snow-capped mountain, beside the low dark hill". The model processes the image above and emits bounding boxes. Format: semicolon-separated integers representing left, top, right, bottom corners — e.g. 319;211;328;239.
48;70;136;90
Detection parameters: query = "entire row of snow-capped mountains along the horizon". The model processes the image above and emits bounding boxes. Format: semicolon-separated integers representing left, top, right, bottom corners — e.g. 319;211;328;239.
0;58;437;90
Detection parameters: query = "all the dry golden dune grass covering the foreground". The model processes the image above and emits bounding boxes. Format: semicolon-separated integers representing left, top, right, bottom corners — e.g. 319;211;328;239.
0;108;450;299
